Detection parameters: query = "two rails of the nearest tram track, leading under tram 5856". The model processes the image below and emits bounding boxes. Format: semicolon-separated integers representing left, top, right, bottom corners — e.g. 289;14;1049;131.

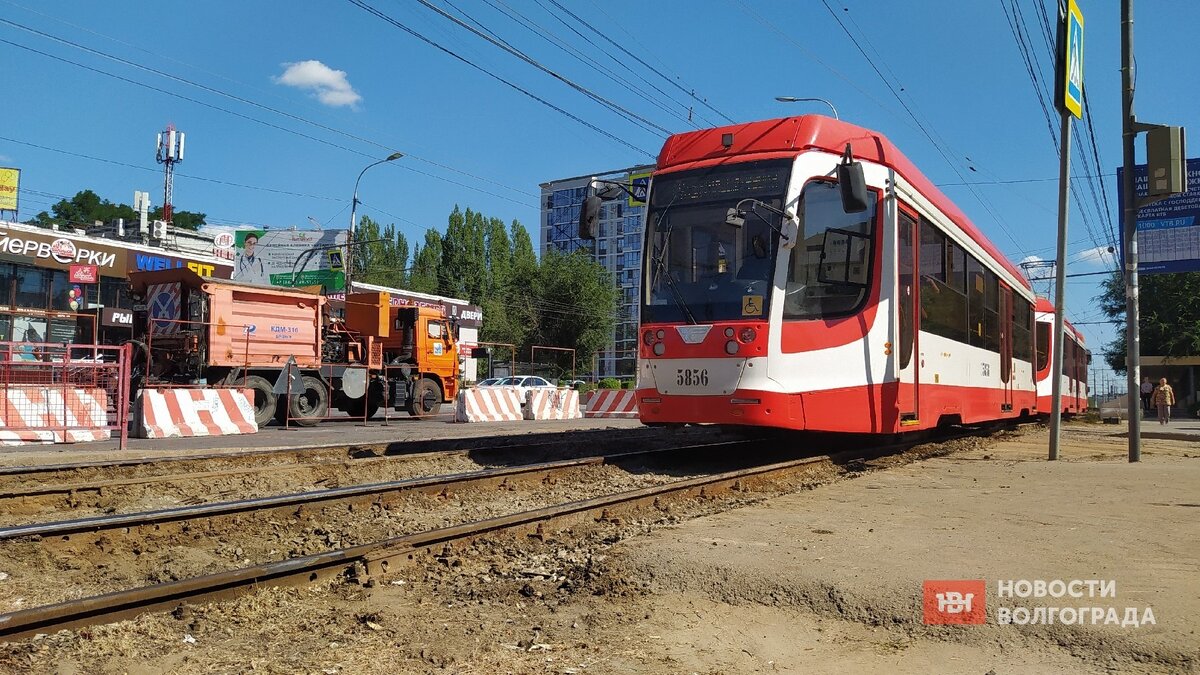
0;422;1022;639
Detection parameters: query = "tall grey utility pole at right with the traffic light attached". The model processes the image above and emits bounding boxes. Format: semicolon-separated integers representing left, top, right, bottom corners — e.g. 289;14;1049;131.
1121;0;1141;461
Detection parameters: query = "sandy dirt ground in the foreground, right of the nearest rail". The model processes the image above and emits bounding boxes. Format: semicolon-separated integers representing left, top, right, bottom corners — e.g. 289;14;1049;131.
0;426;1200;675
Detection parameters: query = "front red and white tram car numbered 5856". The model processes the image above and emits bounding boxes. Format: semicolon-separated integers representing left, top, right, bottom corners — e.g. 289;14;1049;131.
580;115;1038;434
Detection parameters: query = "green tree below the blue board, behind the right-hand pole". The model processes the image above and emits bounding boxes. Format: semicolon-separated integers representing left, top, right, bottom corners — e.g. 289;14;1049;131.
1097;271;1200;372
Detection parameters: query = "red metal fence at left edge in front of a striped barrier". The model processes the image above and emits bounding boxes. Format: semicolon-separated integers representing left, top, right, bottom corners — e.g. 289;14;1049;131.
0;342;131;449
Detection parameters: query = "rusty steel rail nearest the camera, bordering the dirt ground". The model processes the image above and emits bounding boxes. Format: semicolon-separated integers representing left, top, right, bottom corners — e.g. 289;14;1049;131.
0;447;873;640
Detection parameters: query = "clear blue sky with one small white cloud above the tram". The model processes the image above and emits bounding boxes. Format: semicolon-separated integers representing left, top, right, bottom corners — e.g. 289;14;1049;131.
0;0;1200;381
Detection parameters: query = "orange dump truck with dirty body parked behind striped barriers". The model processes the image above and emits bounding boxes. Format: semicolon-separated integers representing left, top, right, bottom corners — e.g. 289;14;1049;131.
130;268;461;425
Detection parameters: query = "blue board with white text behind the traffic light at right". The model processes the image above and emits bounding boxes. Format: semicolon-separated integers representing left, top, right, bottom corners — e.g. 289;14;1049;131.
1117;159;1200;274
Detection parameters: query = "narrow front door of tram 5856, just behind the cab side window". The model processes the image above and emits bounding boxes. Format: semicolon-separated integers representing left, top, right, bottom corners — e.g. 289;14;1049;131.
895;211;920;428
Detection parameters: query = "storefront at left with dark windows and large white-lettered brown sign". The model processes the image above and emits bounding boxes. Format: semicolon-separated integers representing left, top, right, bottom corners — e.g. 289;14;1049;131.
0;221;233;344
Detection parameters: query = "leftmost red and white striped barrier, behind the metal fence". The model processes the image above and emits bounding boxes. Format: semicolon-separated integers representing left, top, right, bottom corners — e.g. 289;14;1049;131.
0;384;113;446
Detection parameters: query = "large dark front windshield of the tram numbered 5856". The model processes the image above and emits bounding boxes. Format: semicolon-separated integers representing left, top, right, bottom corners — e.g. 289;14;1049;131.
642;160;791;323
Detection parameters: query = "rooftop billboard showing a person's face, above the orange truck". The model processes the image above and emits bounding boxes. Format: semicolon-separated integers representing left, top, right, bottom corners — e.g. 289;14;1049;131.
233;229;349;292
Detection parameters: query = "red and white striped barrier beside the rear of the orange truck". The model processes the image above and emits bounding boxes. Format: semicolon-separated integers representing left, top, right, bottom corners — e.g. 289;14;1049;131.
134;389;258;438
